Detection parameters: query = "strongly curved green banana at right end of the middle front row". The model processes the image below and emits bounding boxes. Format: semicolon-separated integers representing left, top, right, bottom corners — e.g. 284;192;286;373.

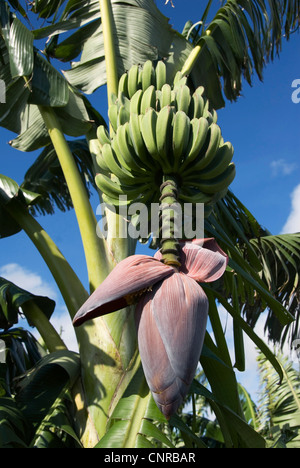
182;123;222;176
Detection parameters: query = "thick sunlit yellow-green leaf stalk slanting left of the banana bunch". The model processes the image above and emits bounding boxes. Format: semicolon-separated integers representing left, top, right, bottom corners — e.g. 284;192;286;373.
39;107;109;292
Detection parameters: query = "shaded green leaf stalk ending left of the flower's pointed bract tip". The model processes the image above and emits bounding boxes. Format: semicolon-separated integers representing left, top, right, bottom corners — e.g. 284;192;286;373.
5;200;88;318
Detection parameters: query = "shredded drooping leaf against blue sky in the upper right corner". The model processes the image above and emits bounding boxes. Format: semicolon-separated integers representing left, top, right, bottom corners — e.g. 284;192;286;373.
183;0;300;109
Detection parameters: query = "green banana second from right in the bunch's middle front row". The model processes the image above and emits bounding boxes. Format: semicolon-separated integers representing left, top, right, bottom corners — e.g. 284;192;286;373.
179;117;209;173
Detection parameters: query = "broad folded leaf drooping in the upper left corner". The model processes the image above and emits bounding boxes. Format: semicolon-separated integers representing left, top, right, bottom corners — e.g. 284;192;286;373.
0;6;101;151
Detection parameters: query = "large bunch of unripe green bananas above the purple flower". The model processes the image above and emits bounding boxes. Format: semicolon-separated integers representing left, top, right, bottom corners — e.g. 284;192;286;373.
96;61;235;205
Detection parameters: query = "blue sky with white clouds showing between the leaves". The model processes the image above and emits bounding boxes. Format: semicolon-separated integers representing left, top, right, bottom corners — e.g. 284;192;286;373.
0;0;300;400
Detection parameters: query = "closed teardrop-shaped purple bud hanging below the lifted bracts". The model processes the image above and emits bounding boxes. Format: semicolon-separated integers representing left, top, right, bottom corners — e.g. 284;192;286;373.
136;272;208;418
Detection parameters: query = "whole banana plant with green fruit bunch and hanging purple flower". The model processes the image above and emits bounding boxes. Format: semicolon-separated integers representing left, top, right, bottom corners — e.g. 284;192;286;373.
0;0;299;448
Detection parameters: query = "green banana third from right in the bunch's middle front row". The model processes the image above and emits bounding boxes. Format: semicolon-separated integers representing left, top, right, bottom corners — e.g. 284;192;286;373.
172;111;191;171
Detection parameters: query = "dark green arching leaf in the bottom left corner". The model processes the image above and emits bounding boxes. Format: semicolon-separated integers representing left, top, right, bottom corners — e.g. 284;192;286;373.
0;344;81;448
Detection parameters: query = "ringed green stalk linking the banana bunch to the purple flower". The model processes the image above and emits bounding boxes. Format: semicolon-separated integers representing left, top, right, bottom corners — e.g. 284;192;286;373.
160;175;181;268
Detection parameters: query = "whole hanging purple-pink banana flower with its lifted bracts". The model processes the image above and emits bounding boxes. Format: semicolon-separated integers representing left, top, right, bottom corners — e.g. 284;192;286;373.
73;238;228;419
